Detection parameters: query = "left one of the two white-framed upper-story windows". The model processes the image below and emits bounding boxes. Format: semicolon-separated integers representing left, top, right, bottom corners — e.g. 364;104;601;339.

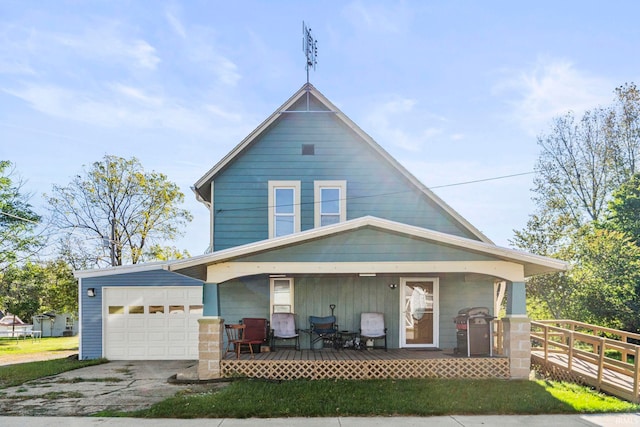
269;181;300;237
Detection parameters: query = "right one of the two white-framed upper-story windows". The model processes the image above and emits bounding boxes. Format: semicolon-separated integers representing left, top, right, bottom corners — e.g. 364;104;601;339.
314;181;347;227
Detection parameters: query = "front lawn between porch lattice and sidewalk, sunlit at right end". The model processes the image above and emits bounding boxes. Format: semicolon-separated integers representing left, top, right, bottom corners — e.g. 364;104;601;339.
97;380;640;418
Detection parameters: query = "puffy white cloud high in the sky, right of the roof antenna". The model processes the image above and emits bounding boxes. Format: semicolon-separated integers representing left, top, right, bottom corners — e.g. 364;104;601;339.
494;58;614;133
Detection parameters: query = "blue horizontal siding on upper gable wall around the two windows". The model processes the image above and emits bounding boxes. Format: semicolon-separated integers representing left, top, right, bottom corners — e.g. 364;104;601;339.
214;108;474;250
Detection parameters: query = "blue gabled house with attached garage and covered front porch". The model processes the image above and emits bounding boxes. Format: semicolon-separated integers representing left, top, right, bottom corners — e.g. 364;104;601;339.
76;83;567;378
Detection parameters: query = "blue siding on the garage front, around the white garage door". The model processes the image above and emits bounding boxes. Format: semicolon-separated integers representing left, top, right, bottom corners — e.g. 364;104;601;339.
80;270;202;359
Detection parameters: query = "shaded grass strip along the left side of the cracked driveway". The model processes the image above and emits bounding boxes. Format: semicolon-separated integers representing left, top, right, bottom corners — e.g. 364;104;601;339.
0;358;106;389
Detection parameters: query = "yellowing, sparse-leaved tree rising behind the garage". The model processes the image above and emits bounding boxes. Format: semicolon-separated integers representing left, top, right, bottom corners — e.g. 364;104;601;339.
45;156;191;266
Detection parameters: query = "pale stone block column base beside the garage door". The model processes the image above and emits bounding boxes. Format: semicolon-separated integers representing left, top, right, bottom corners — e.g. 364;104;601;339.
198;316;224;380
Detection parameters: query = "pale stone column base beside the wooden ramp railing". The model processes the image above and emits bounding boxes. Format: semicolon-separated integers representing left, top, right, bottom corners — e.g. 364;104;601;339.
502;316;531;379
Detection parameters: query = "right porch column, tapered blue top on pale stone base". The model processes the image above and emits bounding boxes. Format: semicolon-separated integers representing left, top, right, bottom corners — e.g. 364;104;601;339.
502;282;531;379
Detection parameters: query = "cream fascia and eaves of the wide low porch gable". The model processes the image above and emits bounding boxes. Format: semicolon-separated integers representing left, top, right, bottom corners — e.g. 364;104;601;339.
166;216;569;280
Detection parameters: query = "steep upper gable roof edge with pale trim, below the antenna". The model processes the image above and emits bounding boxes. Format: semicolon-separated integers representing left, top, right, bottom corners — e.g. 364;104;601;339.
193;83;492;243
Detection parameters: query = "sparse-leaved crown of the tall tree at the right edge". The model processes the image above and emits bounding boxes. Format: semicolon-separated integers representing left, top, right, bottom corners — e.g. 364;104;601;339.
534;84;640;229
